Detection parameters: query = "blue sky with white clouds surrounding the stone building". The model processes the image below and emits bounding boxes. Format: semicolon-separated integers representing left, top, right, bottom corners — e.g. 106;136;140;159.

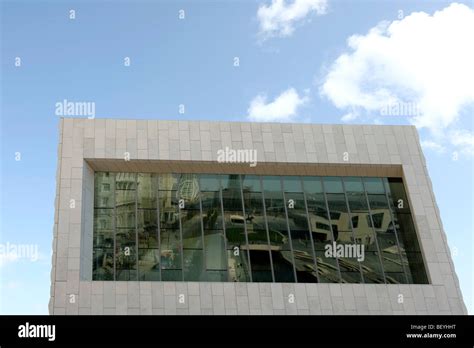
0;0;474;314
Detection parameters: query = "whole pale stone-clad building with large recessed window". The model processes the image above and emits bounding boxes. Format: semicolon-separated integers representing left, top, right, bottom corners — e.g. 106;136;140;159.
49;118;466;314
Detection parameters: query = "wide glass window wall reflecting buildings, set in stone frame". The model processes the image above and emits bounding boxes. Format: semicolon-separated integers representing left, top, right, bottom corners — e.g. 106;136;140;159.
93;172;428;284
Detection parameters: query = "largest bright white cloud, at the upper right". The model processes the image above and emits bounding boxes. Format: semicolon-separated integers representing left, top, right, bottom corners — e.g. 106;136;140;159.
320;3;474;154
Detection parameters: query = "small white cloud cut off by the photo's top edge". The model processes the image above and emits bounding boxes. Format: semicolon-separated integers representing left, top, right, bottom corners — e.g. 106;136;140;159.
257;0;327;38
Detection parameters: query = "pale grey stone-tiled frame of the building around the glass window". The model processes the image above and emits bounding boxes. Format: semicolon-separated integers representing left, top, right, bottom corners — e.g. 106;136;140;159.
49;118;467;315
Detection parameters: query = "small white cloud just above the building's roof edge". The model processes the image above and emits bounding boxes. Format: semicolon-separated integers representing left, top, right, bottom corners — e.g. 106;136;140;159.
247;88;309;122
